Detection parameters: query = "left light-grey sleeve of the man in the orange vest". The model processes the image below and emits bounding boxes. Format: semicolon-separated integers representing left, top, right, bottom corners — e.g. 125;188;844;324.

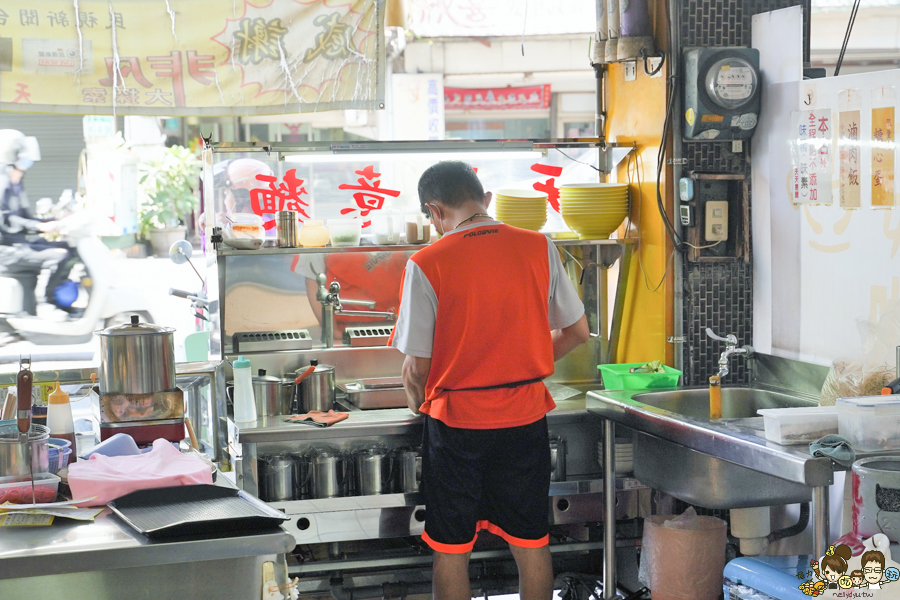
392;260;437;358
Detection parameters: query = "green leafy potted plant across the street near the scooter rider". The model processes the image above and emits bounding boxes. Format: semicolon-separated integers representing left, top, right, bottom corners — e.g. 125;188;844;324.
138;146;200;255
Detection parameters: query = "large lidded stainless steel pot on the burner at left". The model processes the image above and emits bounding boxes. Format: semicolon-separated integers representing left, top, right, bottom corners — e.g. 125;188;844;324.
97;315;176;394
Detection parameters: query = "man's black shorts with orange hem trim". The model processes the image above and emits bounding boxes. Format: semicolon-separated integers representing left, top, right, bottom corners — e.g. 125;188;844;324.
422;415;550;554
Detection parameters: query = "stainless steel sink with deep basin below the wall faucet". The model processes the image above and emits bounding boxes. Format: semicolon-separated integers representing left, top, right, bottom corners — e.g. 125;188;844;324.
587;388;833;508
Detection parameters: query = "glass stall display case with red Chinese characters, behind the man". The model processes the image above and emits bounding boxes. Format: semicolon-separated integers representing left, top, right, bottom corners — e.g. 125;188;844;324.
204;139;632;380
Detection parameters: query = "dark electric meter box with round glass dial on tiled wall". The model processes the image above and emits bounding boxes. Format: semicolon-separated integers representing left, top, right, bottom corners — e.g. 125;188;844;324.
684;48;762;140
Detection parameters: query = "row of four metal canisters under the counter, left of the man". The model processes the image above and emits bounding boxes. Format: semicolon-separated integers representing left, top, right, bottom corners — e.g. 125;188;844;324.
258;446;422;502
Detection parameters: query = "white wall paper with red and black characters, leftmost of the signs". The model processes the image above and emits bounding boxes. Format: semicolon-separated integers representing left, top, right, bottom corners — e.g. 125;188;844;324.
791;109;833;204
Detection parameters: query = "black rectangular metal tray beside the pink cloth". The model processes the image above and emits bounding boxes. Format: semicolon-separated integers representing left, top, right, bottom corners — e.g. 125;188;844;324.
107;484;289;538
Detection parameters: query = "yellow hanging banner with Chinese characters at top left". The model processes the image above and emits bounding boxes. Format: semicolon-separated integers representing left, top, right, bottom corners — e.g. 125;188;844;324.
0;0;384;116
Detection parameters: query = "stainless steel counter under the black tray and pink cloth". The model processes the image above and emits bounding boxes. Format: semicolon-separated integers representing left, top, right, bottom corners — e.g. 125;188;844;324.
0;509;295;600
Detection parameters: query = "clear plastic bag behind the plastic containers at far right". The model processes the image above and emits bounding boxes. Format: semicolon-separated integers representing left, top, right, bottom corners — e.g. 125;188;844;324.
819;301;900;406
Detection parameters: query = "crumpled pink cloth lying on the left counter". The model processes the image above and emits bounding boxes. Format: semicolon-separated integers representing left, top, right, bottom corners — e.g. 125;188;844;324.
69;439;212;506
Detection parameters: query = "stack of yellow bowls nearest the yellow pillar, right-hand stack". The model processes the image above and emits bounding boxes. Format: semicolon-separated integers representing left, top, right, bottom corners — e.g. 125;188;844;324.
559;183;628;239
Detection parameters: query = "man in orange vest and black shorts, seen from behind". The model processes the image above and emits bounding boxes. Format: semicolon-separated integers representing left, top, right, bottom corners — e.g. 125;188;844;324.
392;161;588;600
